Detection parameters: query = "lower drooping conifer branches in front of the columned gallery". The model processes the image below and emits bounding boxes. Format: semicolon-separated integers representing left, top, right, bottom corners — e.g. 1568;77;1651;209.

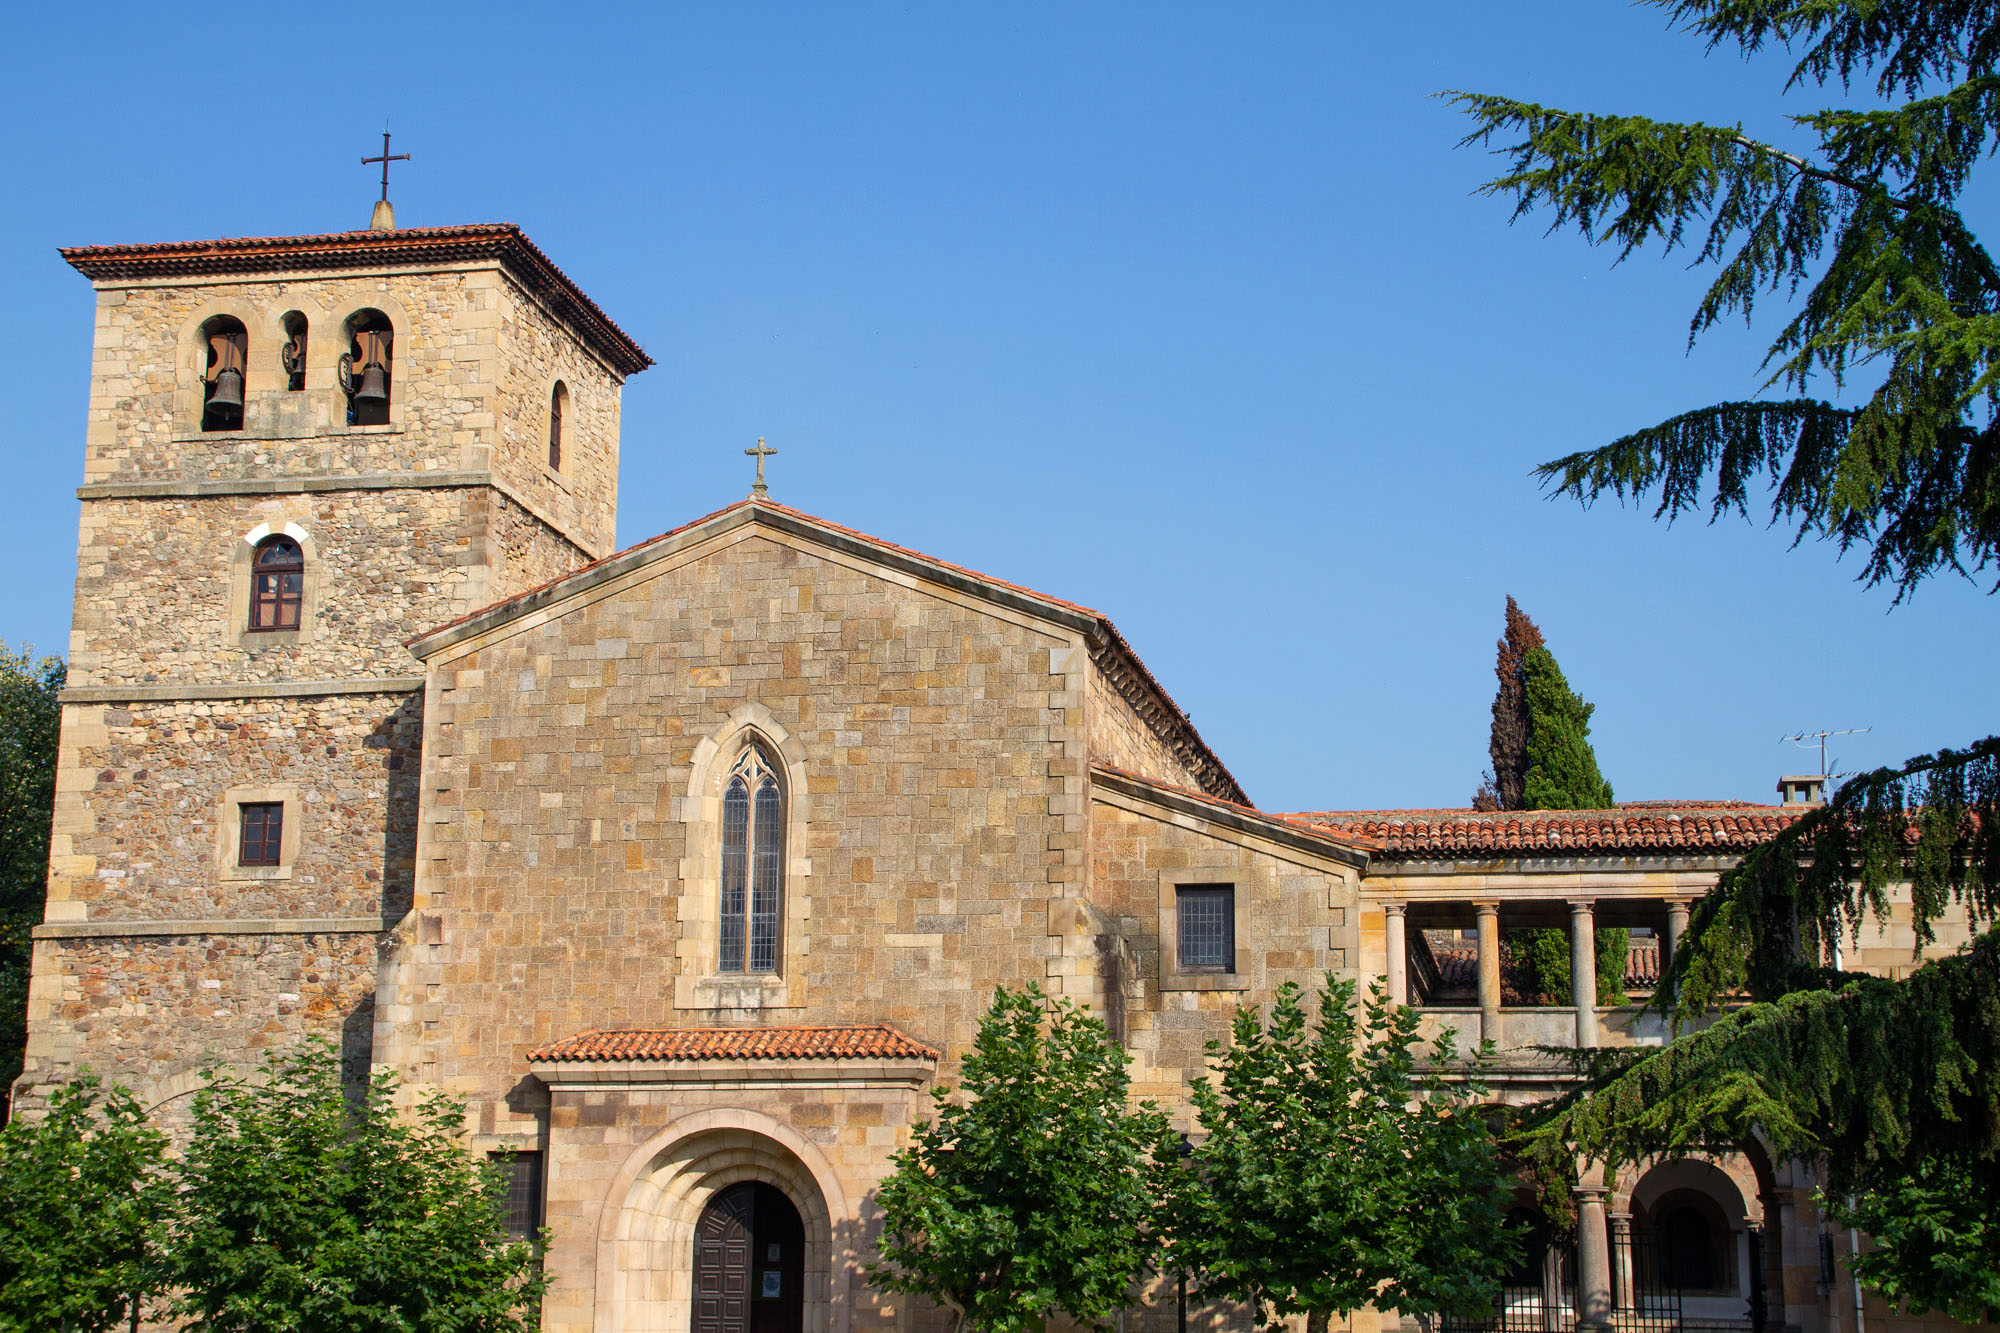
1520;737;2000;1321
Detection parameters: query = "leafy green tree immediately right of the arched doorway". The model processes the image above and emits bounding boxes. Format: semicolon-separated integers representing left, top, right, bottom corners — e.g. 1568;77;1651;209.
868;983;1178;1333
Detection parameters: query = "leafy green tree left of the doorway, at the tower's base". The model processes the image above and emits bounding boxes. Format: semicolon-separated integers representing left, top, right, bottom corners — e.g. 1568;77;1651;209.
170;1041;546;1333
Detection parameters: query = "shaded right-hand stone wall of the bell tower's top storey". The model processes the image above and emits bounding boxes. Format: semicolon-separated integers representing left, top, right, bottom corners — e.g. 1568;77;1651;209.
492;274;624;556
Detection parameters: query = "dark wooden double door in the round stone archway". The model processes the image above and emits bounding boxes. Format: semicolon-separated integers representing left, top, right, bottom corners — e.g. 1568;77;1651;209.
694;1181;806;1333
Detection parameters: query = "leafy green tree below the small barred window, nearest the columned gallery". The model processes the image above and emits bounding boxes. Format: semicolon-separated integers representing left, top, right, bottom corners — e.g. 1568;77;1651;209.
1174;975;1514;1333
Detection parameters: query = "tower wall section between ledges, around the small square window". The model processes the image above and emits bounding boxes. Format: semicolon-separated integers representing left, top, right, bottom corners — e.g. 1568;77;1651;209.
48;695;422;923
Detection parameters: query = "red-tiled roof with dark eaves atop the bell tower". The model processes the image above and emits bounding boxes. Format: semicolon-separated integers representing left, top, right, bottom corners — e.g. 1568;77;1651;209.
60;222;652;374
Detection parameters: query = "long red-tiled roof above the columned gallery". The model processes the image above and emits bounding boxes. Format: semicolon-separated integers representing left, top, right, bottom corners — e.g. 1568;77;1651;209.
1282;801;1812;861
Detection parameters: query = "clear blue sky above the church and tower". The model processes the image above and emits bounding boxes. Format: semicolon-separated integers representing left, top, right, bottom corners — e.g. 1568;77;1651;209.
0;2;2000;809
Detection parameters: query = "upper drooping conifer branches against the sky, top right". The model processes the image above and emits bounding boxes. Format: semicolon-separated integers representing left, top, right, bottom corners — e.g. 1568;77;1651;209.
1448;0;2000;598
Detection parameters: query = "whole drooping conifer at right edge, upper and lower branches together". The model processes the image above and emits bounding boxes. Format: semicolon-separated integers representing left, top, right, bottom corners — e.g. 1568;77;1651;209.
1452;0;2000;1319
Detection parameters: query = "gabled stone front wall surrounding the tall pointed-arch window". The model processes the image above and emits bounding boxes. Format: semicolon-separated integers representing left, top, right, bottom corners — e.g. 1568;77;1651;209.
412;532;1082;1121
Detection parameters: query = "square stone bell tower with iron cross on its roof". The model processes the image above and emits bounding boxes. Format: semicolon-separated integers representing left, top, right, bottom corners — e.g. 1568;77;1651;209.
22;218;652;1119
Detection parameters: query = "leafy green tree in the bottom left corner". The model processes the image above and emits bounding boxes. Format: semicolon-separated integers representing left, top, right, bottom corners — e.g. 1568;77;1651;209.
0;1077;172;1333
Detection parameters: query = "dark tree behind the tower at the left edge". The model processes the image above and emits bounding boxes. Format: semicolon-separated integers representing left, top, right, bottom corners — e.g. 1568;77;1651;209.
0;640;64;1113
